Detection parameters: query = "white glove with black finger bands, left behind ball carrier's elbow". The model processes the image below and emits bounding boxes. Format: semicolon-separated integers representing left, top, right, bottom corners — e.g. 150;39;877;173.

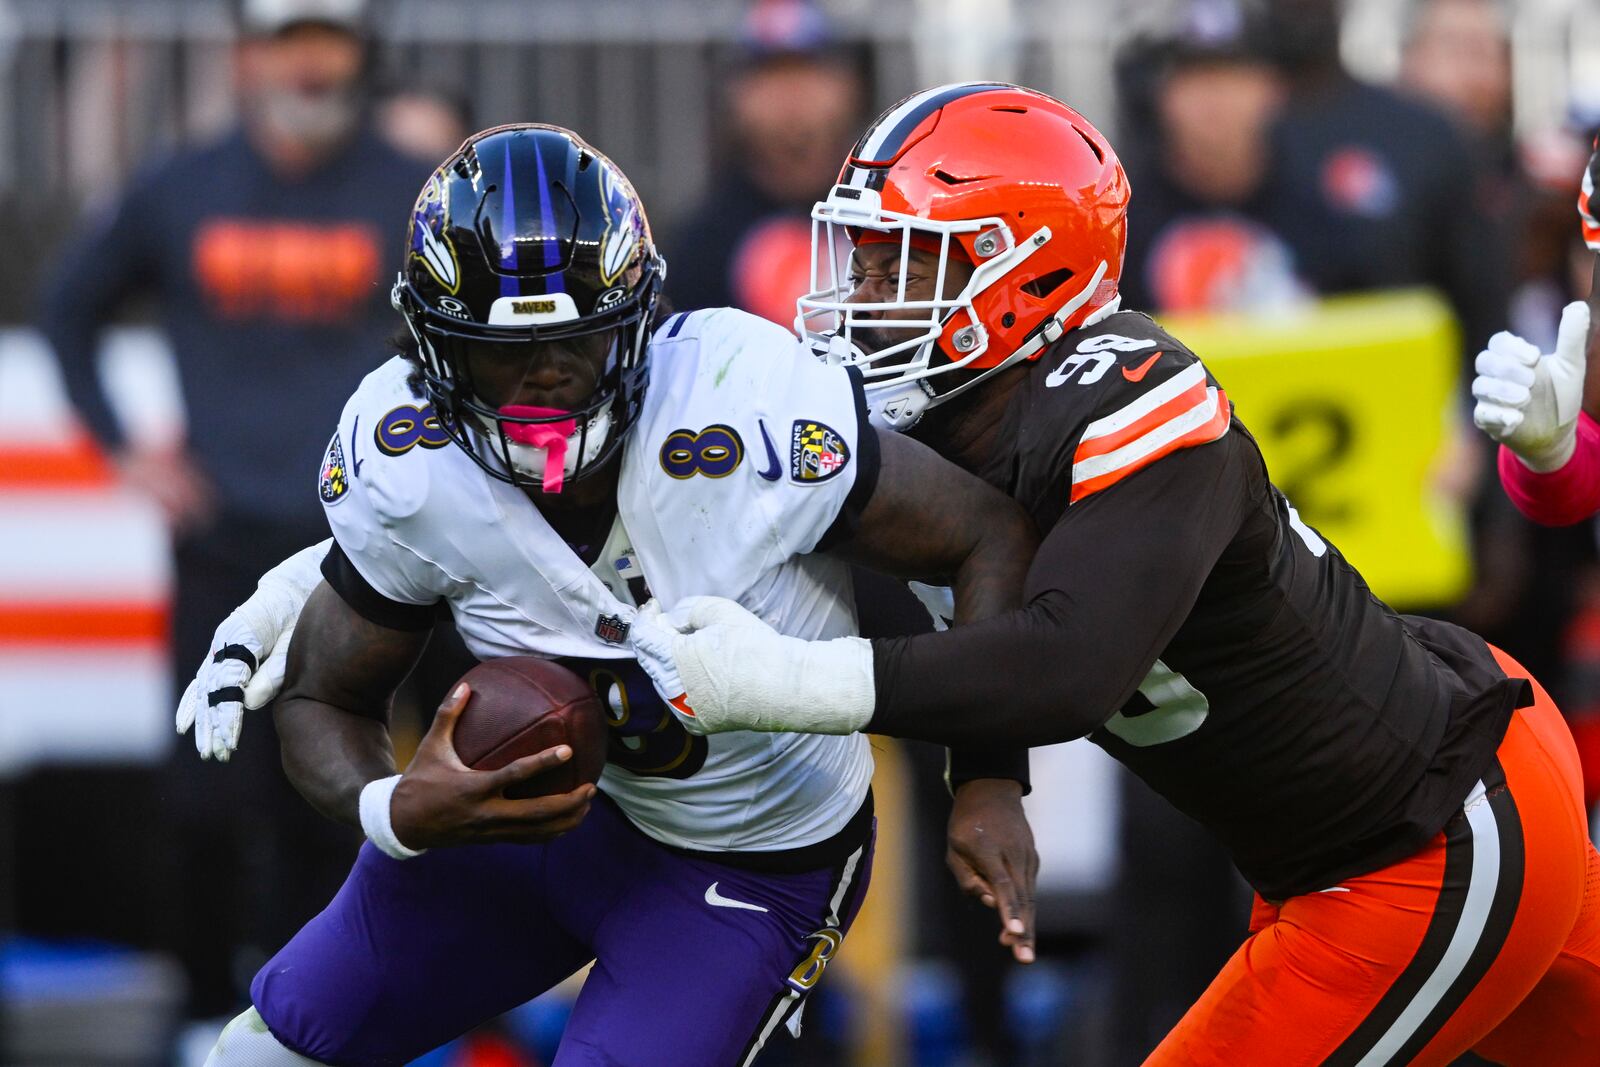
178;537;333;763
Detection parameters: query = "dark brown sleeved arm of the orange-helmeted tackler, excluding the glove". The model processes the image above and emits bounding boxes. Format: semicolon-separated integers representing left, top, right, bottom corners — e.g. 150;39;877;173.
867;437;1241;747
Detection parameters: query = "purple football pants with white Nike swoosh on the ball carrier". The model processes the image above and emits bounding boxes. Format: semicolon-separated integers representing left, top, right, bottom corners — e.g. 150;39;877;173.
251;798;872;1067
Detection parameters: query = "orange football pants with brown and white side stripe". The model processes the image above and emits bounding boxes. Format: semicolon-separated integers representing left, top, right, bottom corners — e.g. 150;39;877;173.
1146;649;1600;1067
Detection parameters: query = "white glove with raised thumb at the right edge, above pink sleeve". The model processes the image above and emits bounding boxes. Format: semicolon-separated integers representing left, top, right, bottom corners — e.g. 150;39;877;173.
1472;301;1589;472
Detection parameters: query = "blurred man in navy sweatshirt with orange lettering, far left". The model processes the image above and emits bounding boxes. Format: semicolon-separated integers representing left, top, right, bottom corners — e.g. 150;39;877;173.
38;0;429;1036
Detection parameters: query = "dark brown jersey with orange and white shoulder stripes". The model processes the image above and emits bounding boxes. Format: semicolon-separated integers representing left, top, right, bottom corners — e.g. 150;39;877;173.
869;312;1528;899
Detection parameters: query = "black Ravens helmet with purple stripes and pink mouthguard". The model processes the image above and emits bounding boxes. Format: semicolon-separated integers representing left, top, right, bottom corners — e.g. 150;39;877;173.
392;123;666;493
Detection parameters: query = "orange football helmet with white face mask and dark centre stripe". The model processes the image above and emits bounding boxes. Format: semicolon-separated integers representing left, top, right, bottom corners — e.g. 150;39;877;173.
795;82;1128;429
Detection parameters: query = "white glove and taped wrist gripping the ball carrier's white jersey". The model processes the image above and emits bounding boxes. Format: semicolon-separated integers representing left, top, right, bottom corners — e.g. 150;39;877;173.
629;597;877;734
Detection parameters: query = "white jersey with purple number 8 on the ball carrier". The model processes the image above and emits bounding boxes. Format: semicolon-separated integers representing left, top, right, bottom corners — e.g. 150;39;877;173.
320;309;877;851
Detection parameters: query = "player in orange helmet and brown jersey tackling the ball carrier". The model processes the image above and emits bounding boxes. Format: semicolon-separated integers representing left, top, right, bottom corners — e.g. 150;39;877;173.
634;83;1600;1067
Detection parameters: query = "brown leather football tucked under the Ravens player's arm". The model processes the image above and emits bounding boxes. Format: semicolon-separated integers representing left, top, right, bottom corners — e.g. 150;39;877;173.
454;656;606;798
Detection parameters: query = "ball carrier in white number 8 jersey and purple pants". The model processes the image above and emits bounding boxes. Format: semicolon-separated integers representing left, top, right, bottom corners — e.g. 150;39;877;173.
179;125;1035;1067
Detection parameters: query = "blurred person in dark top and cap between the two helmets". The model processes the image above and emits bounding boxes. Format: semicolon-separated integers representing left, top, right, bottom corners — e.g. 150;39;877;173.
666;0;864;326
